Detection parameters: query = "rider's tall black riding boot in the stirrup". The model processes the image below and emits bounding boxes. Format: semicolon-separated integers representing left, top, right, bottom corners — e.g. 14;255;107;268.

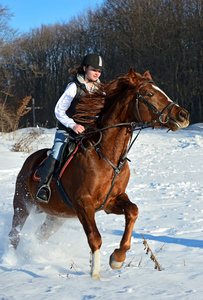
35;155;57;203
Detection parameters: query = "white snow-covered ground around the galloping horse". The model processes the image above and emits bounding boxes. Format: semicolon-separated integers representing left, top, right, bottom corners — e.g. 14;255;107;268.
0;124;203;300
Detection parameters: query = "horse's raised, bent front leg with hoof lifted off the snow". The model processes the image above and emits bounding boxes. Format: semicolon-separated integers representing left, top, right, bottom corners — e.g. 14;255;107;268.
105;193;138;269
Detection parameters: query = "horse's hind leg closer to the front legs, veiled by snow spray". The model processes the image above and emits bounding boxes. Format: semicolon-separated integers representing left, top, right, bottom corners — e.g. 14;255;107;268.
36;214;66;241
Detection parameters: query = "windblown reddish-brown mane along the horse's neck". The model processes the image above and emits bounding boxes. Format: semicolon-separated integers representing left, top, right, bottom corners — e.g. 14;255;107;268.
74;73;150;127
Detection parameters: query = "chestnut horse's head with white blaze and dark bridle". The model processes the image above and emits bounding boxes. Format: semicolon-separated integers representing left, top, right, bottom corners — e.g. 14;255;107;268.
129;69;189;131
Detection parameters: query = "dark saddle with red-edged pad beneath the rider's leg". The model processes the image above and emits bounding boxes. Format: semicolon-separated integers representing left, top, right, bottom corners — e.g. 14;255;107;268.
33;141;80;181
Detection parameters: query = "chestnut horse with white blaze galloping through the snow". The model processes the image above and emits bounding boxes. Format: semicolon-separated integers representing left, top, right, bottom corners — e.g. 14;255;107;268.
9;69;189;279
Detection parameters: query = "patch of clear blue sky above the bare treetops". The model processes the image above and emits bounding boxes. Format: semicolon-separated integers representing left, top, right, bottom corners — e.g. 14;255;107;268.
0;0;104;32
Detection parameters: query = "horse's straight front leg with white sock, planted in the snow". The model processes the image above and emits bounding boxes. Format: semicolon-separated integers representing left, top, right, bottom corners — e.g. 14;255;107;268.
77;201;102;279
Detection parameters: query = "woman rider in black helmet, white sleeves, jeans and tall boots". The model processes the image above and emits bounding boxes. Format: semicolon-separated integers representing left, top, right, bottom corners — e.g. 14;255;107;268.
35;54;103;203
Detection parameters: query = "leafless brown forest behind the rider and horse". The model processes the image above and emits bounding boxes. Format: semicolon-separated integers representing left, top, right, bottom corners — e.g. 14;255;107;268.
0;0;203;132
